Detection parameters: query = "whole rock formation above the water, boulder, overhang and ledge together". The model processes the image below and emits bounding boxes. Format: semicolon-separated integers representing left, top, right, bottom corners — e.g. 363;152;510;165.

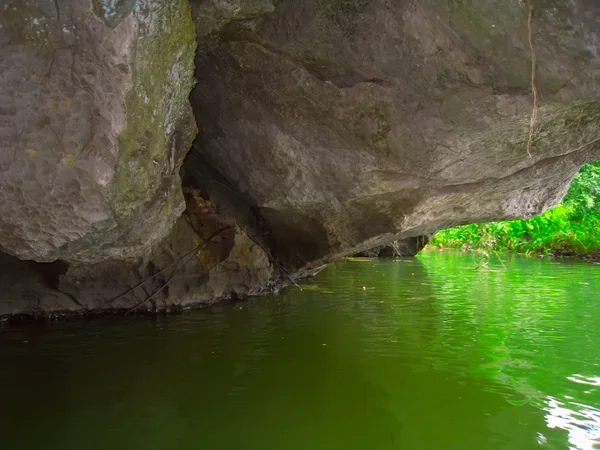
0;0;600;316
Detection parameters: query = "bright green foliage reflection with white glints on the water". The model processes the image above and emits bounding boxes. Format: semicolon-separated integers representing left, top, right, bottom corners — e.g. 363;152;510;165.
422;254;600;450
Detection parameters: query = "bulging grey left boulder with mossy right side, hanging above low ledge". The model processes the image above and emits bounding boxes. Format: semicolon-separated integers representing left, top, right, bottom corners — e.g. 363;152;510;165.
0;0;197;264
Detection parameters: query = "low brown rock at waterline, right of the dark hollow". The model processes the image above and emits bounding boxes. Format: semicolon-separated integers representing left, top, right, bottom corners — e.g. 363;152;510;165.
55;217;277;316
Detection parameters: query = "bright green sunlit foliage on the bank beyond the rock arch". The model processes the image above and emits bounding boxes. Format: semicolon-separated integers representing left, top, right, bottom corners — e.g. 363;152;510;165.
430;161;600;255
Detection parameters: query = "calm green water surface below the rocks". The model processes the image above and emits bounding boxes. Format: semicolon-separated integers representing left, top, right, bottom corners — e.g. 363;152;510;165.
0;251;600;450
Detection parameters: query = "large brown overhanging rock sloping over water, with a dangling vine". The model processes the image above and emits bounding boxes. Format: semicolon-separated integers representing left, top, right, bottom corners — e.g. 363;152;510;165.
189;0;600;269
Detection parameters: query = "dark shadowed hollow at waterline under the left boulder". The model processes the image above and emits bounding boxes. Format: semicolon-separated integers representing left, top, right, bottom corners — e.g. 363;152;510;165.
0;251;73;317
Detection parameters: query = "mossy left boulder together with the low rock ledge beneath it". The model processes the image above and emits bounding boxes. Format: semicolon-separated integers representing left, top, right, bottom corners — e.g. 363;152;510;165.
0;0;276;316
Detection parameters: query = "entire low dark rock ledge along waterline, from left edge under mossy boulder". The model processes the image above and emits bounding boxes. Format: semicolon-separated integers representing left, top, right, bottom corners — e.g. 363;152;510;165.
0;217;280;322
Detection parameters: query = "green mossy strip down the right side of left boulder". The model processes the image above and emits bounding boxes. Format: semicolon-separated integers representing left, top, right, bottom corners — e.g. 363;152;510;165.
112;0;197;217
